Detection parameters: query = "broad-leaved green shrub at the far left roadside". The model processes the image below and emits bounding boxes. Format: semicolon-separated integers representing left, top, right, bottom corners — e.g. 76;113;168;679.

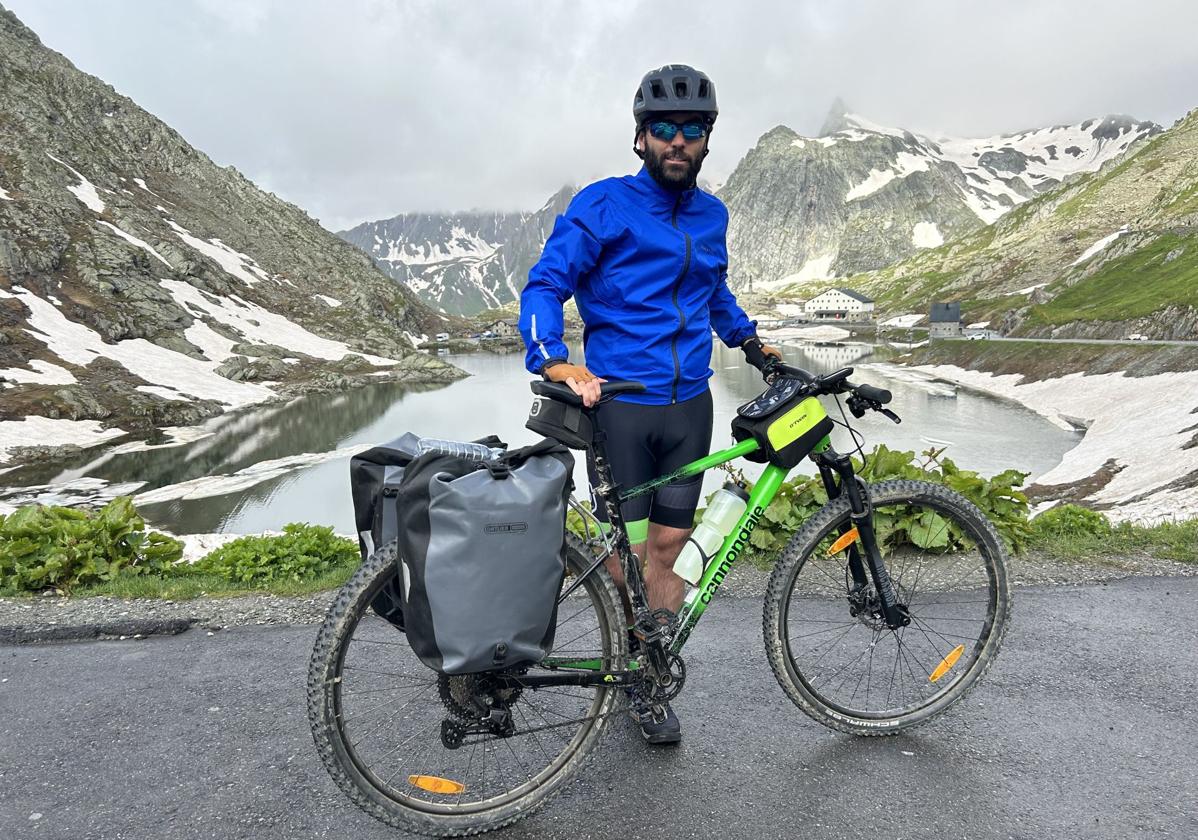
0;496;183;592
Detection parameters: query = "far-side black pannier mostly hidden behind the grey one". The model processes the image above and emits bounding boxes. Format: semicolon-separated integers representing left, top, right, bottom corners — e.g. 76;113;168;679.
350;433;506;629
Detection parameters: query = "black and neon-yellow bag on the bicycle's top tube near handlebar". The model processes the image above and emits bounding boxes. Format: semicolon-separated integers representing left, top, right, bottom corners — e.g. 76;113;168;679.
732;379;833;470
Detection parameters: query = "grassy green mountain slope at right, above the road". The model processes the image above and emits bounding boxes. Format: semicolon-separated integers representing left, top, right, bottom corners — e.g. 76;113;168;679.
833;109;1198;339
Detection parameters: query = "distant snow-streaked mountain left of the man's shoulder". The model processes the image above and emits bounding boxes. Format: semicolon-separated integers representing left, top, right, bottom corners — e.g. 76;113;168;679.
338;187;575;315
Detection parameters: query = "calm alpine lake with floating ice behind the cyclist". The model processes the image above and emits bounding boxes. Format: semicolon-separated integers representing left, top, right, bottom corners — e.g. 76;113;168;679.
0;342;1081;534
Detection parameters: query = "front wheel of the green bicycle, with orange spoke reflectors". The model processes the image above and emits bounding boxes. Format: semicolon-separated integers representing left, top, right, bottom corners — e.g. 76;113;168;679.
763;481;1011;735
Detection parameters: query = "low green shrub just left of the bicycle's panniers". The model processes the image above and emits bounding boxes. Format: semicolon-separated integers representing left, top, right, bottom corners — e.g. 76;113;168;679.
194;522;361;586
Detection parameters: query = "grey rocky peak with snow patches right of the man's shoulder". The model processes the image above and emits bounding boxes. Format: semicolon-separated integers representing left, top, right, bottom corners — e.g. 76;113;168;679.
719;101;1161;291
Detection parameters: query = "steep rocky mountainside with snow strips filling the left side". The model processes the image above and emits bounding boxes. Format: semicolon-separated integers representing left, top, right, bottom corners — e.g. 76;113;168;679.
0;3;460;457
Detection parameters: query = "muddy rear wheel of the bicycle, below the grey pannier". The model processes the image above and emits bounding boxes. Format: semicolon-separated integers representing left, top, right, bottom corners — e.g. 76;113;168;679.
308;537;627;836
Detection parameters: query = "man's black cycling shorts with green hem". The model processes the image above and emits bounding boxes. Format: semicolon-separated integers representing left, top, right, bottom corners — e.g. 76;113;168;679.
587;391;712;543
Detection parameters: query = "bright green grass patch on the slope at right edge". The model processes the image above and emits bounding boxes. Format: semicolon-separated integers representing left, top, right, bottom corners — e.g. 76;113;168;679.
1028;234;1198;325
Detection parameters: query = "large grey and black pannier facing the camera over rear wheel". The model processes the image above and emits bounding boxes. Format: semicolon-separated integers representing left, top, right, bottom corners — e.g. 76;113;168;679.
395;440;574;673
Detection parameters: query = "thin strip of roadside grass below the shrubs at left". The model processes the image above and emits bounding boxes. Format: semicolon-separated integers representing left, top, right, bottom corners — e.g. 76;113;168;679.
0;560;361;600
